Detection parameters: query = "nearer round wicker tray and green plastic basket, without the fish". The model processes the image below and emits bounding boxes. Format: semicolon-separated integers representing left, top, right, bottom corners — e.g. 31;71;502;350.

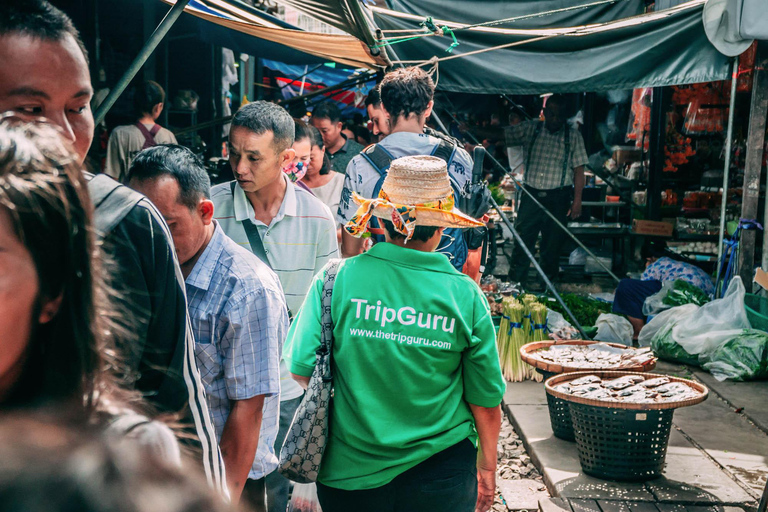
545;371;708;481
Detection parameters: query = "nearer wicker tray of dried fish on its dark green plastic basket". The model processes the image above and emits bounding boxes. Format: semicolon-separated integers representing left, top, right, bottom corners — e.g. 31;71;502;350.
545;371;709;481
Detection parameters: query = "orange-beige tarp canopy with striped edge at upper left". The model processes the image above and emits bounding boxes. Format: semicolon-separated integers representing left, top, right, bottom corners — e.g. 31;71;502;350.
162;0;387;69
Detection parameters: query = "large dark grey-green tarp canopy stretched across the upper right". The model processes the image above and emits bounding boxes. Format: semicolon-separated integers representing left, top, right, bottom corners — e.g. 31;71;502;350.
370;0;729;94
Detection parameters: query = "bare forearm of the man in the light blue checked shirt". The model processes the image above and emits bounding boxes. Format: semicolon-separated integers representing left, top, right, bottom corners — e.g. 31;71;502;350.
219;395;264;503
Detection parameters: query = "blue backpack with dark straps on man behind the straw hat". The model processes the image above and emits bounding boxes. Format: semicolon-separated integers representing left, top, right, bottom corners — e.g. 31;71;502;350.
360;139;467;271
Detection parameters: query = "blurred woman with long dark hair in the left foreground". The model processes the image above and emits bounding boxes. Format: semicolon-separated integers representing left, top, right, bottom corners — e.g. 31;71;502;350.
0;118;180;462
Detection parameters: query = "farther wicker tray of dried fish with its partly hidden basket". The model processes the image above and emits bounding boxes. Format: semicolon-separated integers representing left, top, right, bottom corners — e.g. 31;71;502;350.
520;340;656;441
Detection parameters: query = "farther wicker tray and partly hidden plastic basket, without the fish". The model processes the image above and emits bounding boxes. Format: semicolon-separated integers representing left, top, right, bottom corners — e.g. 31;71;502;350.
520;340;656;441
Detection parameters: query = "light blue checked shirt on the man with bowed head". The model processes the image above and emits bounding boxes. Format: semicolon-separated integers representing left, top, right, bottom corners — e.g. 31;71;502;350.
186;221;288;479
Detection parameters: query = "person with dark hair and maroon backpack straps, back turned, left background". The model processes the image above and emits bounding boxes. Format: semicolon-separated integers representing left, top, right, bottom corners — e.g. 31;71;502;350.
104;80;176;183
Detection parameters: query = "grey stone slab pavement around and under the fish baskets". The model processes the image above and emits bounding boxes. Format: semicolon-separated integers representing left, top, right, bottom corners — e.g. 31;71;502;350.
504;363;768;512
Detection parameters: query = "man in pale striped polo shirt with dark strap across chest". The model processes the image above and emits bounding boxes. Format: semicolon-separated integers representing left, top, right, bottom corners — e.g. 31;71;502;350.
211;101;339;512
